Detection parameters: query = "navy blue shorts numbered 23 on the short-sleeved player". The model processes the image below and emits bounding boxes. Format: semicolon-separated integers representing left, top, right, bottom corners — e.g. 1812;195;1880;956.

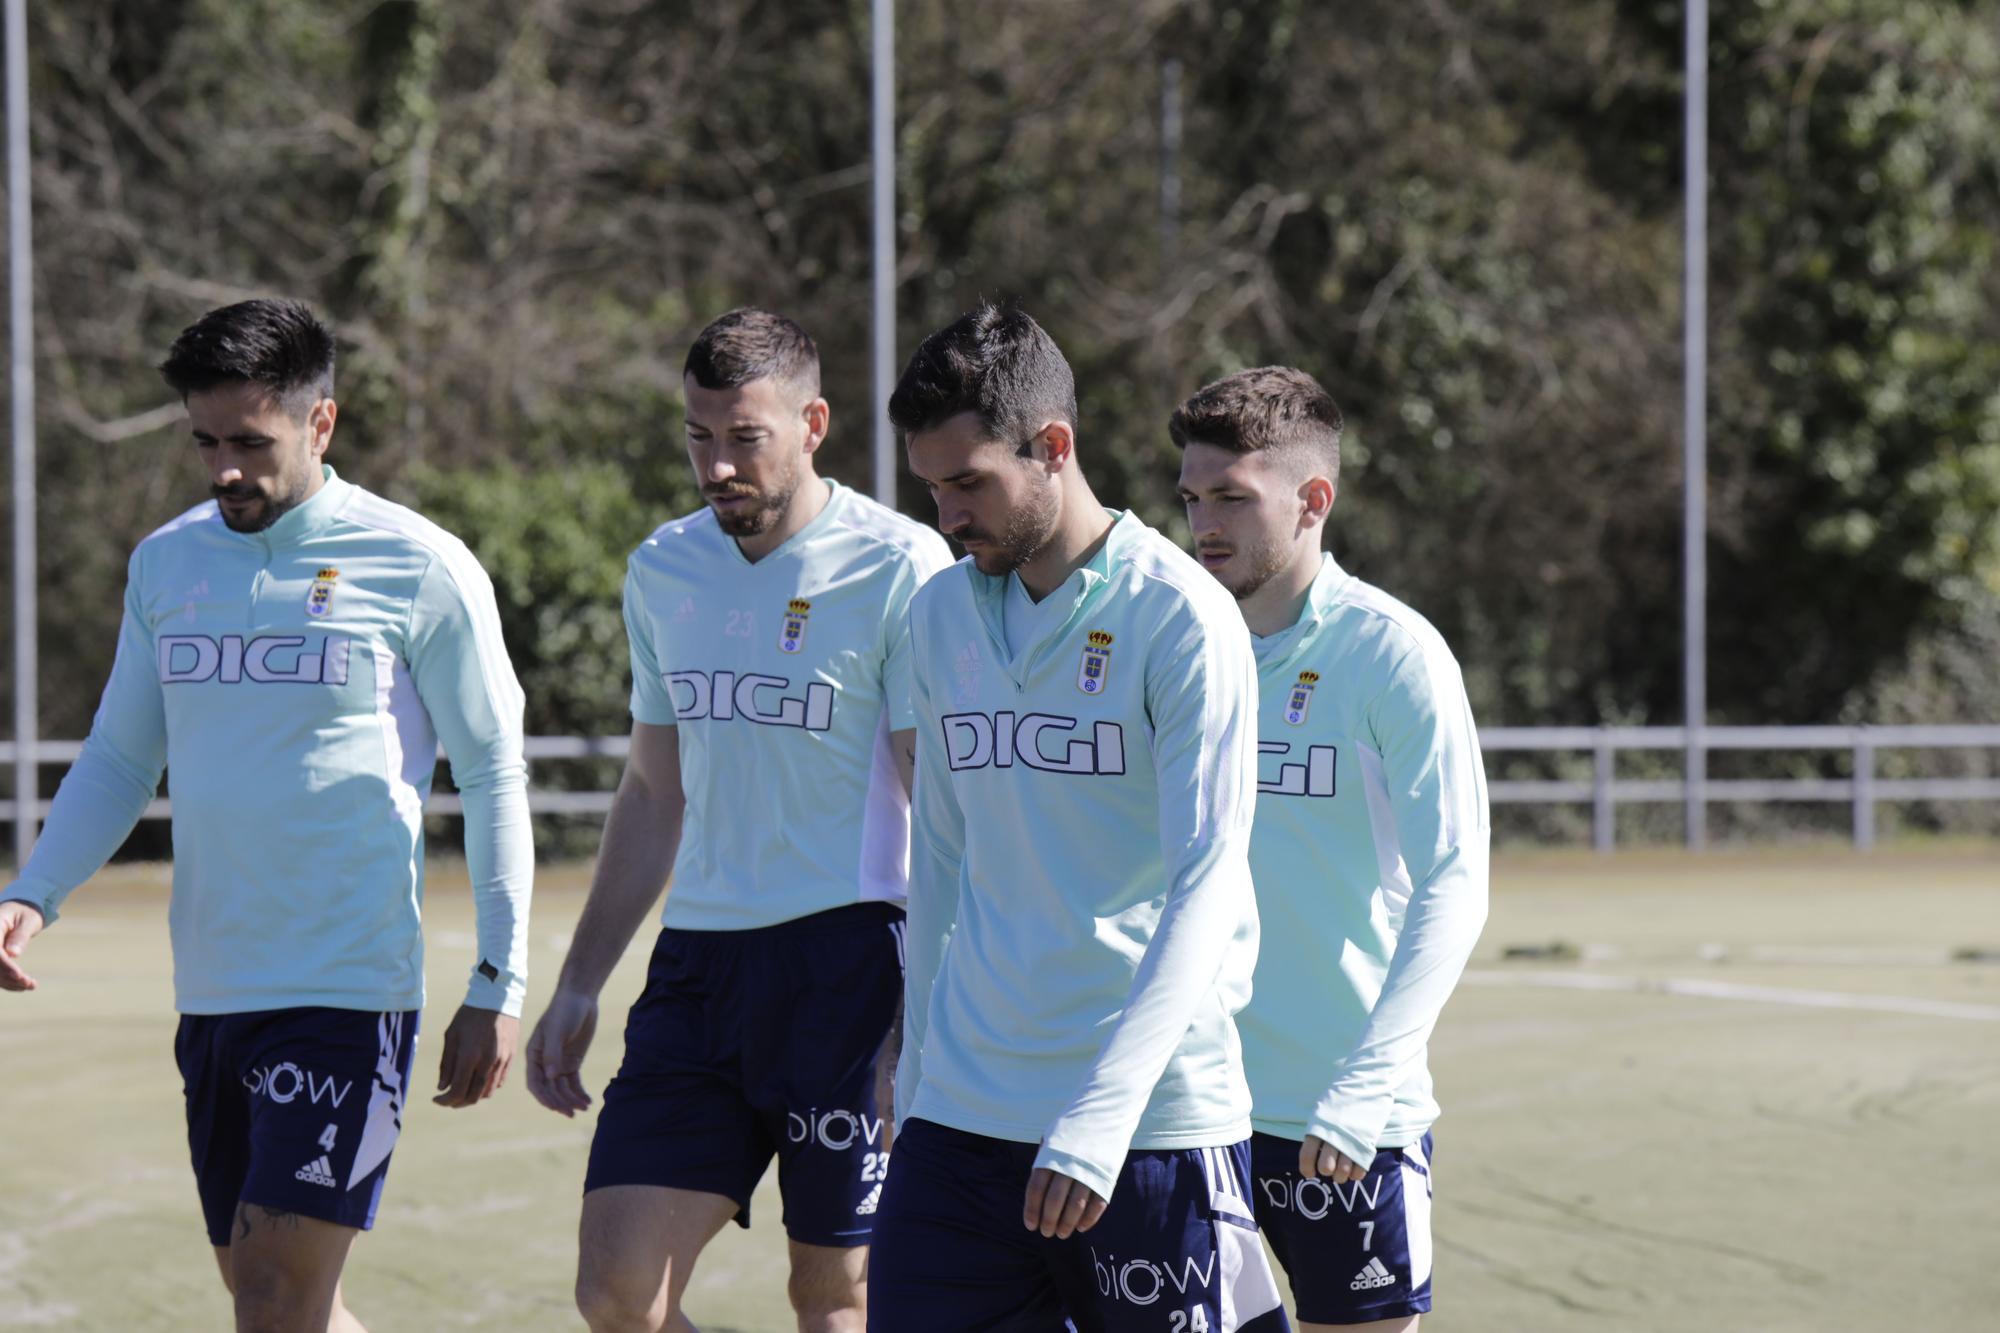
584;903;902;1247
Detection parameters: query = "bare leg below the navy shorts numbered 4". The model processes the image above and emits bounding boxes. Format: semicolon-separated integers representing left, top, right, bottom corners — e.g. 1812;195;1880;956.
216;1203;366;1333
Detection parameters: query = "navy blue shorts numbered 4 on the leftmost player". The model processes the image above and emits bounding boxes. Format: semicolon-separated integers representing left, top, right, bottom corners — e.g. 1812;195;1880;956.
174;1009;418;1245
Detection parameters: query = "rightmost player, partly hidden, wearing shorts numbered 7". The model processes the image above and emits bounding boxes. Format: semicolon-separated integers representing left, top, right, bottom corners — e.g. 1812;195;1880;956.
1168;366;1490;1329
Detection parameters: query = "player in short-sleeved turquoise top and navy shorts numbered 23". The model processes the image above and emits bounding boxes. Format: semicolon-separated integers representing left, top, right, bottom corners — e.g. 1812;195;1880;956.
528;310;950;1333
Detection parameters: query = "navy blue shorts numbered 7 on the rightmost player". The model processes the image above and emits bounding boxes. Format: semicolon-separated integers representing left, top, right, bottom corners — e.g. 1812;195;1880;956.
1250;1135;1430;1323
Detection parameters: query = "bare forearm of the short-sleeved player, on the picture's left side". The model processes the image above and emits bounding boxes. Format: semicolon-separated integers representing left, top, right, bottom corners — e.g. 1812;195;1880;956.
558;773;686;997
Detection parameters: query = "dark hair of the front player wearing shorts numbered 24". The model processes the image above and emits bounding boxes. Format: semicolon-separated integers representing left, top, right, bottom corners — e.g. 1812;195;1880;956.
888;304;1076;452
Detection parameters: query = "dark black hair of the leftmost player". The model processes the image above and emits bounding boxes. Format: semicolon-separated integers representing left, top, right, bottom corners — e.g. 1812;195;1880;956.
160;300;334;414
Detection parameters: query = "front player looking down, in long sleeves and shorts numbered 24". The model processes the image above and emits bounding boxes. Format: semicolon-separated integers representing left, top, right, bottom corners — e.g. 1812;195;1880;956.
870;306;1286;1333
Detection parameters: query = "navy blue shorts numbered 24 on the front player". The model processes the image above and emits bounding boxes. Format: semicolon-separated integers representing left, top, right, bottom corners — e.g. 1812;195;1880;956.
868;1119;1290;1333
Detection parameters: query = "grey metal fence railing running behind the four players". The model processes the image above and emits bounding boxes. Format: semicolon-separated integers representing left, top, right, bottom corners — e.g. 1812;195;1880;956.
11;725;2000;851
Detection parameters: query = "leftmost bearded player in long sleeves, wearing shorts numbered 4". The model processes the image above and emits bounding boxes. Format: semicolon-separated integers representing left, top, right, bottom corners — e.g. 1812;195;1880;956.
0;300;534;1331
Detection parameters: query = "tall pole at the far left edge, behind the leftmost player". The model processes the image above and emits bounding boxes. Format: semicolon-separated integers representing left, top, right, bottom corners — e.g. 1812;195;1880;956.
6;0;42;865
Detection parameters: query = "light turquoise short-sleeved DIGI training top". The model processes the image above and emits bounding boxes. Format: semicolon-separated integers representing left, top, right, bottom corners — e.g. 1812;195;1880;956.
626;482;952;931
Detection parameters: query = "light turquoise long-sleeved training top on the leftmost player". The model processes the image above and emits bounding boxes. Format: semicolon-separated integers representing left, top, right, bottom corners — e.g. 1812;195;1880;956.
0;468;534;1015
